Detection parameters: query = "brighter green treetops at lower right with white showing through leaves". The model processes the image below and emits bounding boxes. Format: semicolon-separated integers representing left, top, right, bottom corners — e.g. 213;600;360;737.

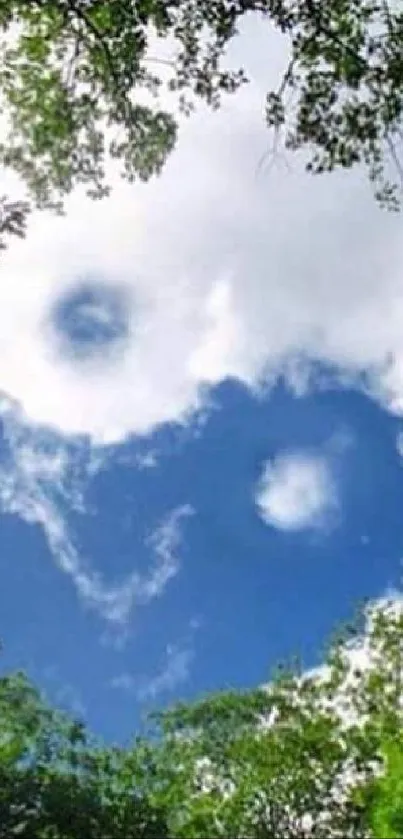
144;609;403;839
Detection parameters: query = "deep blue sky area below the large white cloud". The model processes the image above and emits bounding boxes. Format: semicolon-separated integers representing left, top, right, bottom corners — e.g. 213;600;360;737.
1;380;403;740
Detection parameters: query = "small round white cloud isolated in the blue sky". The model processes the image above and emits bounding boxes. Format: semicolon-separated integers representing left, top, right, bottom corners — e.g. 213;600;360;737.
255;451;337;530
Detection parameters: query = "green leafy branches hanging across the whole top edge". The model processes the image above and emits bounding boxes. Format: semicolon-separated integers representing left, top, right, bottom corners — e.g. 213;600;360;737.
0;0;403;217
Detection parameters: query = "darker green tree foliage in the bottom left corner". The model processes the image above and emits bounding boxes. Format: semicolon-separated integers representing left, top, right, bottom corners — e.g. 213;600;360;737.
0;673;167;839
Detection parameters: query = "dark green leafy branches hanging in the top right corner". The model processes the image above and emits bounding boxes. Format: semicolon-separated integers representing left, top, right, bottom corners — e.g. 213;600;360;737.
267;0;403;209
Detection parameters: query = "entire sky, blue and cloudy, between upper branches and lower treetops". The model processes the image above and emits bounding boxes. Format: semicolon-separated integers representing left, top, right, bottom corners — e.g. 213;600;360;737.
0;18;403;741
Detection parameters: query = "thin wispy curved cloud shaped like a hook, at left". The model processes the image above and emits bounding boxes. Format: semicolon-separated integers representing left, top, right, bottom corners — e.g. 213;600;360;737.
0;400;193;625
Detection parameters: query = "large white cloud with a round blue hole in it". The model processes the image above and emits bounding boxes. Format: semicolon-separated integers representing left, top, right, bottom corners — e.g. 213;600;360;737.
0;20;403;442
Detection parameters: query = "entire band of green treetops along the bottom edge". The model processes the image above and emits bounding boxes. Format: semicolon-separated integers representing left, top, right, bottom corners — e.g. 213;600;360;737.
0;604;403;839
